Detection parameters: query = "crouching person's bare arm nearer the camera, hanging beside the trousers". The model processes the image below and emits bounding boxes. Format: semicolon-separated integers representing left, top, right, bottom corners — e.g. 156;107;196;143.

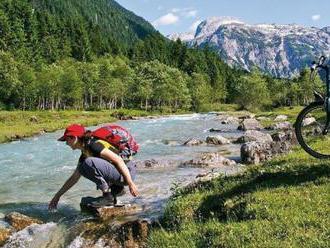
100;148;139;196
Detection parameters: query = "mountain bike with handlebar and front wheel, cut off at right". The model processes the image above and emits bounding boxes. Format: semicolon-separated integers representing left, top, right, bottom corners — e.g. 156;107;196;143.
295;56;330;159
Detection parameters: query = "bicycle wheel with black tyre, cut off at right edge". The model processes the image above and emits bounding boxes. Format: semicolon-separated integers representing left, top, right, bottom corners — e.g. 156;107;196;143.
295;102;330;159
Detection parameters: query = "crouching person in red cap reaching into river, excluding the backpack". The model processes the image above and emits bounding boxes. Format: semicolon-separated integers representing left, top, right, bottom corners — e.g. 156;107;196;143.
48;124;138;210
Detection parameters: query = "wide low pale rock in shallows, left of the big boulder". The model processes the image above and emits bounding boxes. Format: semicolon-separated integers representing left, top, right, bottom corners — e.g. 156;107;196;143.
180;152;236;168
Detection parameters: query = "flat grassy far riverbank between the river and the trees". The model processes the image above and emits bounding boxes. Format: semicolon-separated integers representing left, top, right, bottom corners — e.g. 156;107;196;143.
0;109;196;143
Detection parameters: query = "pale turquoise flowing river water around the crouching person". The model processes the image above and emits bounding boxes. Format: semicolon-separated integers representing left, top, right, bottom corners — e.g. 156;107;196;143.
0;114;245;247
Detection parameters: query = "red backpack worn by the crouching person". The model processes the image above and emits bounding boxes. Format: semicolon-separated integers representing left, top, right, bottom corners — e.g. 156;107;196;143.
91;124;139;157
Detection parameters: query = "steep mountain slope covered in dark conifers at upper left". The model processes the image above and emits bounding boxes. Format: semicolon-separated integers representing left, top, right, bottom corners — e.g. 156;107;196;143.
0;0;158;62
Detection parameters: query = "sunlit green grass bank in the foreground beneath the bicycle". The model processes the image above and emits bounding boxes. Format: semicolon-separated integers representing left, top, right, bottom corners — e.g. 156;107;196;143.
148;147;330;248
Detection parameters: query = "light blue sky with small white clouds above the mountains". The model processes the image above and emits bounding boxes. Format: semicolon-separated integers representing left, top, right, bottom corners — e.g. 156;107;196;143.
116;0;330;35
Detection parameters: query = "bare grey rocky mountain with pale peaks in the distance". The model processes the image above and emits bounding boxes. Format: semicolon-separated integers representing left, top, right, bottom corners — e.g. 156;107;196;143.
169;17;330;77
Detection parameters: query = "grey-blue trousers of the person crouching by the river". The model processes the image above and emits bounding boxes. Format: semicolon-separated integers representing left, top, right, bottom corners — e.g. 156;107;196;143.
78;157;136;192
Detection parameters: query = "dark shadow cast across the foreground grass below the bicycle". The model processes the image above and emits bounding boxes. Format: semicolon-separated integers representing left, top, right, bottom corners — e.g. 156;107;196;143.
195;163;330;221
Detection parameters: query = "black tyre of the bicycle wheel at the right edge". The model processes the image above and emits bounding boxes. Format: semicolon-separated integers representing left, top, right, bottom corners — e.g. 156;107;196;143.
295;102;330;159
